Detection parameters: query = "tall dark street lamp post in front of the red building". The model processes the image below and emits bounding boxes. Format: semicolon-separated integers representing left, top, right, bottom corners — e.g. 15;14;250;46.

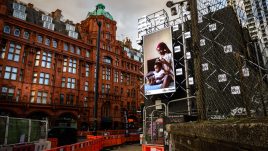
93;6;102;136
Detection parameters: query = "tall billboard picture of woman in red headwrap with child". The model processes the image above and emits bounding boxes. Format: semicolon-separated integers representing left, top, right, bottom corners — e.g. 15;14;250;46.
143;28;176;95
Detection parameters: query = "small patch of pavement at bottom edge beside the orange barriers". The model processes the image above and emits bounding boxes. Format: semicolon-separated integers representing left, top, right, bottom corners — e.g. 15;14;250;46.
104;144;142;151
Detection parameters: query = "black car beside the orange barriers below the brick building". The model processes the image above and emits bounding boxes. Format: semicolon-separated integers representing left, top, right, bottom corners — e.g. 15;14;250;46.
48;127;77;146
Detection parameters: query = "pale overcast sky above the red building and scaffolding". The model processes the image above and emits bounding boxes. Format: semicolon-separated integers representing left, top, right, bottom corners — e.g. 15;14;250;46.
21;0;171;48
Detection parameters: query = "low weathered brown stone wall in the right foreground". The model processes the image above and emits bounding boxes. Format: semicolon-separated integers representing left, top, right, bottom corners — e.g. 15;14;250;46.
167;119;268;151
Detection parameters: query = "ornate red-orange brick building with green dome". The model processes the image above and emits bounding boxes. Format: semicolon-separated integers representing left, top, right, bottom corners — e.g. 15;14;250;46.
0;0;143;129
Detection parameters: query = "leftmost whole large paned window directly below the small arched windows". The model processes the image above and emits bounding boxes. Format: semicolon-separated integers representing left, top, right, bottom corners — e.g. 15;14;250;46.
7;42;21;62
